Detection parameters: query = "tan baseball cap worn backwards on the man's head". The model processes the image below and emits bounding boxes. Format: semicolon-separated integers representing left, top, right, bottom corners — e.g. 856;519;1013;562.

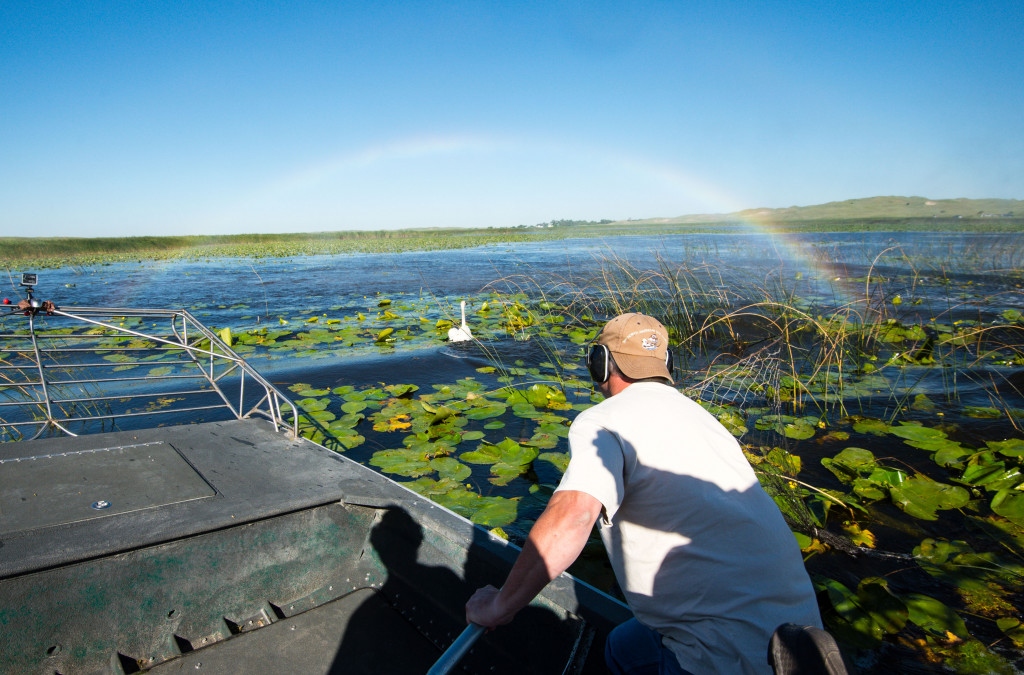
597;313;673;382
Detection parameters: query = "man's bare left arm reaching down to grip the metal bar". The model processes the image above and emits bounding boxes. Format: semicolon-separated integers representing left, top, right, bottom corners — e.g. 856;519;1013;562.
466;490;601;628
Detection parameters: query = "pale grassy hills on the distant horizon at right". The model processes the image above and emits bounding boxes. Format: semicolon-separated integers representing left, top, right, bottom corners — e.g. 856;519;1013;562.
633;197;1024;224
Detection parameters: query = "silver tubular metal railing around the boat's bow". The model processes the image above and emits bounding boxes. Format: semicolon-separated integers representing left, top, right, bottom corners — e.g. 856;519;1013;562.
0;301;299;440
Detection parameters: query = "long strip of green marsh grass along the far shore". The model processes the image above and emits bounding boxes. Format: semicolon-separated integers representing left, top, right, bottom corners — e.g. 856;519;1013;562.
8;217;1024;268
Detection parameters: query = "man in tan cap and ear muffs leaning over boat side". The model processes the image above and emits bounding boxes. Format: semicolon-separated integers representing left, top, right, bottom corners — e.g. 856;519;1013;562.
466;313;821;674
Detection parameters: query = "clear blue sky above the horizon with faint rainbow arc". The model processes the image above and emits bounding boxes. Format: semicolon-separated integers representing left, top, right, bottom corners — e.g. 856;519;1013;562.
0;0;1024;237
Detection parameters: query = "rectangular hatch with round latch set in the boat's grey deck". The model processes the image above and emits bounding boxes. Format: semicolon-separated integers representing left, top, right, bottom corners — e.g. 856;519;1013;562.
0;441;216;534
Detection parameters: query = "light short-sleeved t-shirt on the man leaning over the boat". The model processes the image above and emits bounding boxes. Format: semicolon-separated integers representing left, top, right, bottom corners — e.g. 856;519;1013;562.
558;382;821;674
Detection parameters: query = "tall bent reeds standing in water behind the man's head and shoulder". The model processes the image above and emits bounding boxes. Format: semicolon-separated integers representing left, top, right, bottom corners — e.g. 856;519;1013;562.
483;240;1024;522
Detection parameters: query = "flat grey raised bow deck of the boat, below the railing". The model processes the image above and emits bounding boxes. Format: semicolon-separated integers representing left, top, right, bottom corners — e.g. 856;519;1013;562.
0;420;377;577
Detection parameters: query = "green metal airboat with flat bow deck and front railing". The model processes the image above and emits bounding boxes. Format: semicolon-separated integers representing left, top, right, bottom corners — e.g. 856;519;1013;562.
0;289;630;675
